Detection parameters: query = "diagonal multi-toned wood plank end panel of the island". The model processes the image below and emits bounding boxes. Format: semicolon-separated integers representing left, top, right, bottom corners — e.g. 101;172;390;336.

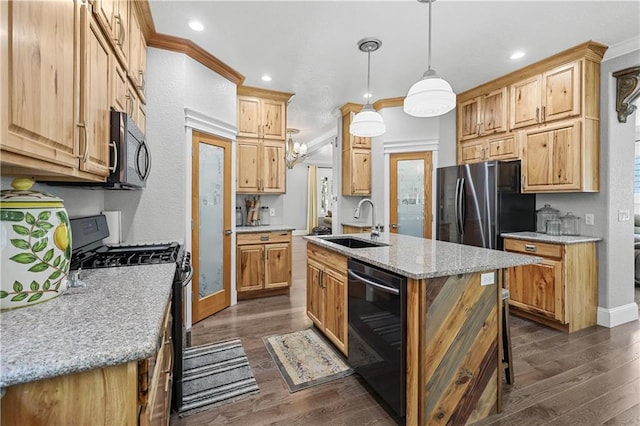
420;272;500;425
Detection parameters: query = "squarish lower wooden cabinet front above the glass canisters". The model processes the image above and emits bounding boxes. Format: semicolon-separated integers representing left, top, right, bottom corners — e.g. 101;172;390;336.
522;121;581;192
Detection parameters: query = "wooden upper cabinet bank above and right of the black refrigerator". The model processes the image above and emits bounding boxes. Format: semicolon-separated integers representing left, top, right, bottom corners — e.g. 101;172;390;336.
457;41;607;193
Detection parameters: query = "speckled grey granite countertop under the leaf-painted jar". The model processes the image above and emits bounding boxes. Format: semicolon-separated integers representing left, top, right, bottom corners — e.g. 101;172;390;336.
0;263;176;387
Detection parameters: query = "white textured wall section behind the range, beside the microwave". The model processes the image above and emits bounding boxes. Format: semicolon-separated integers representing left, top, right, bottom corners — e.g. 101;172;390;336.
105;48;187;241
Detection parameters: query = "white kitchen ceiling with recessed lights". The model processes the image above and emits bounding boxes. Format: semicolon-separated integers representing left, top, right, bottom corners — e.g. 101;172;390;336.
150;0;640;144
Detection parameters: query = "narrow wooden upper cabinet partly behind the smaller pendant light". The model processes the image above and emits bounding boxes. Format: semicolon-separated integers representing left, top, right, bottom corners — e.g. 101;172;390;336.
341;103;371;196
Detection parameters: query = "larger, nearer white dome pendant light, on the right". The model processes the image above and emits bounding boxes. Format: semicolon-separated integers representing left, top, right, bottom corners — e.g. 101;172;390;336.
404;0;456;117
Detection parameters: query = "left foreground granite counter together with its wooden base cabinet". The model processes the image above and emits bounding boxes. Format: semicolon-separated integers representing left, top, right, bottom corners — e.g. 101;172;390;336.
0;264;176;425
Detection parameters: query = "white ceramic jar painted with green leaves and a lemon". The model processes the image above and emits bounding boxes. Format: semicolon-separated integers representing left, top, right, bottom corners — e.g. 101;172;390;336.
0;179;71;309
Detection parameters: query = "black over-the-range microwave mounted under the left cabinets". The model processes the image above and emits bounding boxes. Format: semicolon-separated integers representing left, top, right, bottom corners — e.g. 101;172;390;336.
105;111;151;189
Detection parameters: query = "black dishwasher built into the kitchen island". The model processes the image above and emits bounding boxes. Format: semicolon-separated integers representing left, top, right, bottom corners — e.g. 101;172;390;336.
347;259;407;418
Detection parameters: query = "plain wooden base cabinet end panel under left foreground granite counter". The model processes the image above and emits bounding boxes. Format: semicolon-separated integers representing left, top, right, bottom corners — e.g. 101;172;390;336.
0;361;139;426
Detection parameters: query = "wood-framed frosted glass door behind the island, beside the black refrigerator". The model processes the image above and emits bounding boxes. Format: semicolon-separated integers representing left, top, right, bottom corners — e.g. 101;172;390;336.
389;152;432;238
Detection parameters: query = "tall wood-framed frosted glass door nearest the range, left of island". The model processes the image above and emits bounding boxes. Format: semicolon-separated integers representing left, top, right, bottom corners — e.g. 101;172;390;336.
192;132;231;322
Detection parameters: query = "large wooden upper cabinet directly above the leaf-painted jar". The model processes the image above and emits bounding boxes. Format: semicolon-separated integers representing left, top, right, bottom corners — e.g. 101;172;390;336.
0;0;112;181
